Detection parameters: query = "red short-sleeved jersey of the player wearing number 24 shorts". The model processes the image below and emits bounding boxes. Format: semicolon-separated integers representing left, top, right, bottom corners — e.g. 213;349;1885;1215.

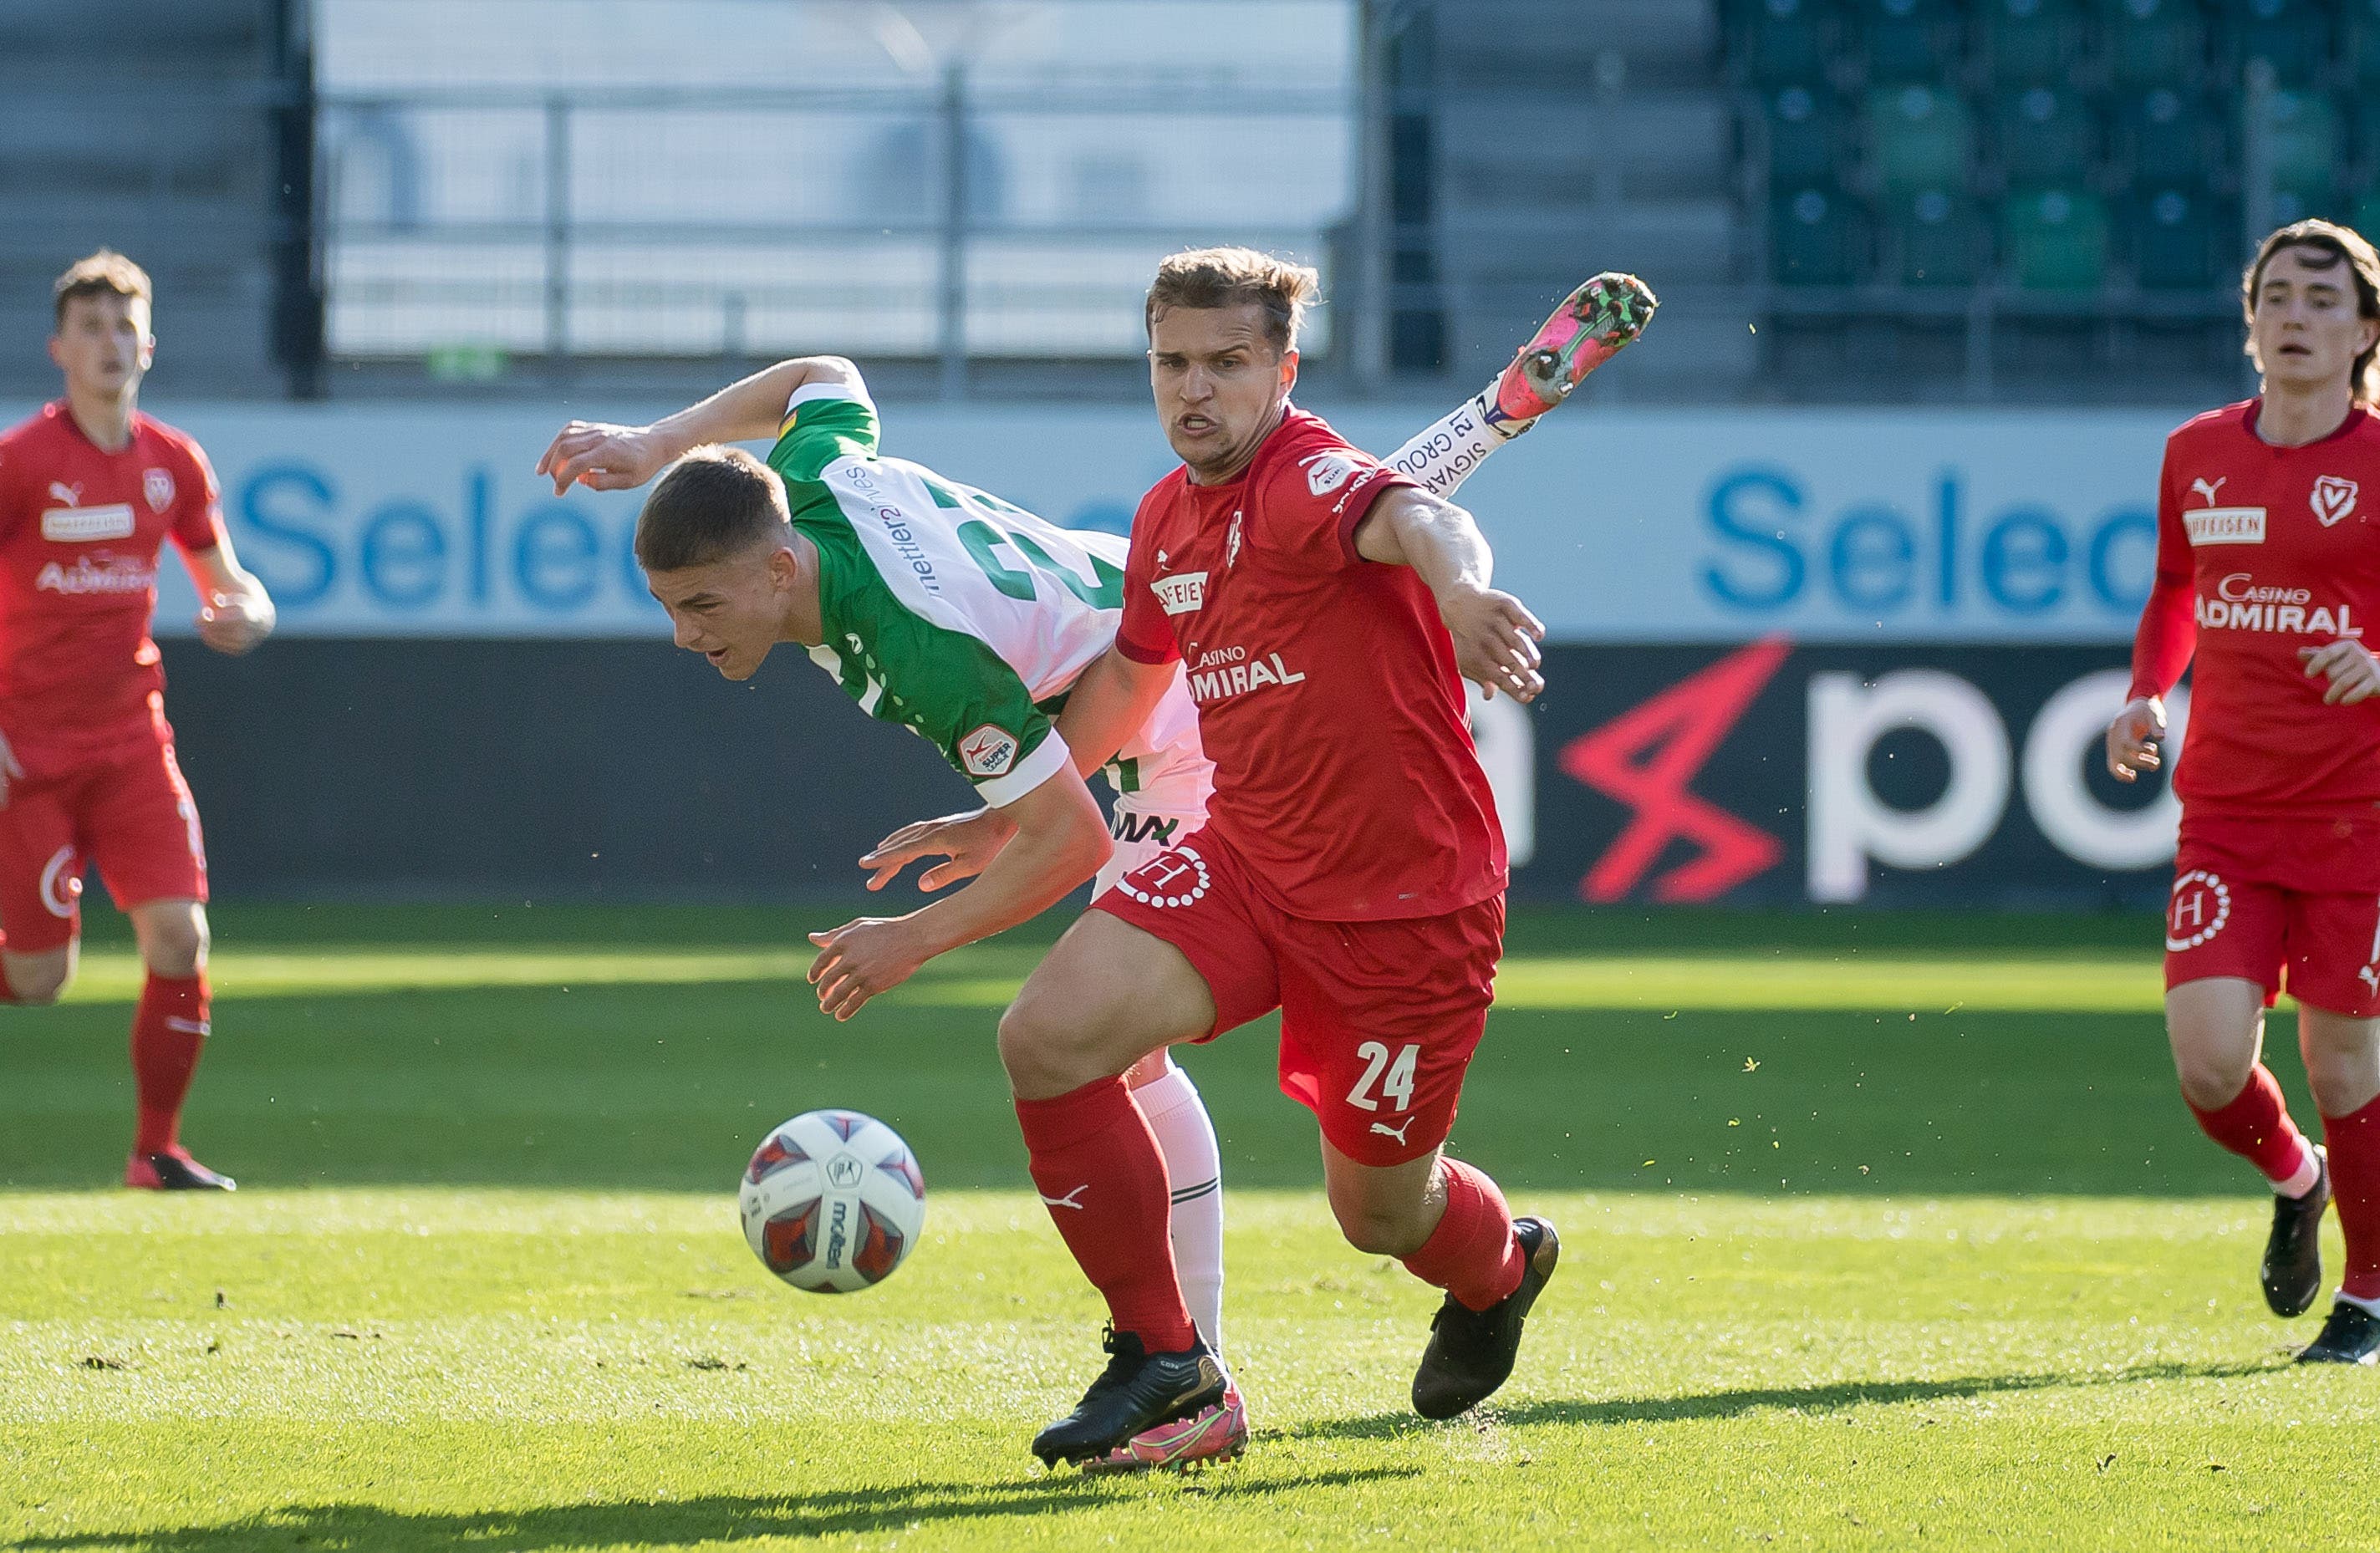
1116;407;1504;923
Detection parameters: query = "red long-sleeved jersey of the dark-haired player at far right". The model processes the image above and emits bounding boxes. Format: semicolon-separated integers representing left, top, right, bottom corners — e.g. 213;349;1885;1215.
2133;400;2380;818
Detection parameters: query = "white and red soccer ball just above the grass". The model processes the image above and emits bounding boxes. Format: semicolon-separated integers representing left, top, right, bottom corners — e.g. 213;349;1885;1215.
736;1111;925;1294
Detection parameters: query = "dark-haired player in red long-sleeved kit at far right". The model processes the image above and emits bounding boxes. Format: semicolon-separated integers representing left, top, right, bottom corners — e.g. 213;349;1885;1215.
2107;221;2380;1365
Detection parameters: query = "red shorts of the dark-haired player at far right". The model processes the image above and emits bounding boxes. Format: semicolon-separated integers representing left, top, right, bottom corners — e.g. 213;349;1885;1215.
2166;811;2380;1018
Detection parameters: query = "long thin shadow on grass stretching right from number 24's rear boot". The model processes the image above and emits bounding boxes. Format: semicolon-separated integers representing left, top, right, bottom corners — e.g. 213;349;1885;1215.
1287;1358;2287;1438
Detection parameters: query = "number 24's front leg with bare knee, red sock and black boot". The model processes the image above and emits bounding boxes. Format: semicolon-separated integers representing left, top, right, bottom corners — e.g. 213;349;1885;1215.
1000;911;1228;1465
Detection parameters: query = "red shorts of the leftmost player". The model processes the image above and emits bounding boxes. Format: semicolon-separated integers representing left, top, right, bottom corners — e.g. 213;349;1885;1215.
0;740;207;954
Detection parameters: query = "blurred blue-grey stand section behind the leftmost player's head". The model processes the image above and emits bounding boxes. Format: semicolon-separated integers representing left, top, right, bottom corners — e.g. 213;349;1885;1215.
0;0;319;395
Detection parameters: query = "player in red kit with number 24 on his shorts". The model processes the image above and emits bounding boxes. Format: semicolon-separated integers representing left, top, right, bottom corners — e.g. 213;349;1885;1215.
1000;250;1585;1463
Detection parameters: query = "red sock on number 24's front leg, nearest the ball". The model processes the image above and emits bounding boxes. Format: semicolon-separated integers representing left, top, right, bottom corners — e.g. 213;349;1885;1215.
1017;1077;1197;1353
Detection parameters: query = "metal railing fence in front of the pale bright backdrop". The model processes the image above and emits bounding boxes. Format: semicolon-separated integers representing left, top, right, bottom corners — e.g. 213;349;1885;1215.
319;75;1357;392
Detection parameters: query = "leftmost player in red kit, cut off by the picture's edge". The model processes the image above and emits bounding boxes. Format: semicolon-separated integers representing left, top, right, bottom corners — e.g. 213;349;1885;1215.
0;250;273;1192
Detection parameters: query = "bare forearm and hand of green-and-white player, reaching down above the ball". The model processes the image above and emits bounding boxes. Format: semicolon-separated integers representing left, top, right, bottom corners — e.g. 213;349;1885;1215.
809;766;1114;1021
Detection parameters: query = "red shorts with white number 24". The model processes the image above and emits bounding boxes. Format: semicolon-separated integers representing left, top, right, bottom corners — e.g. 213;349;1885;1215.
1093;830;1504;1165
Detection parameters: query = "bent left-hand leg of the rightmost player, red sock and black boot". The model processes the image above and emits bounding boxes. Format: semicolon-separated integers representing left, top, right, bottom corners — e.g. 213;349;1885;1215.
2166;975;2330;1315
